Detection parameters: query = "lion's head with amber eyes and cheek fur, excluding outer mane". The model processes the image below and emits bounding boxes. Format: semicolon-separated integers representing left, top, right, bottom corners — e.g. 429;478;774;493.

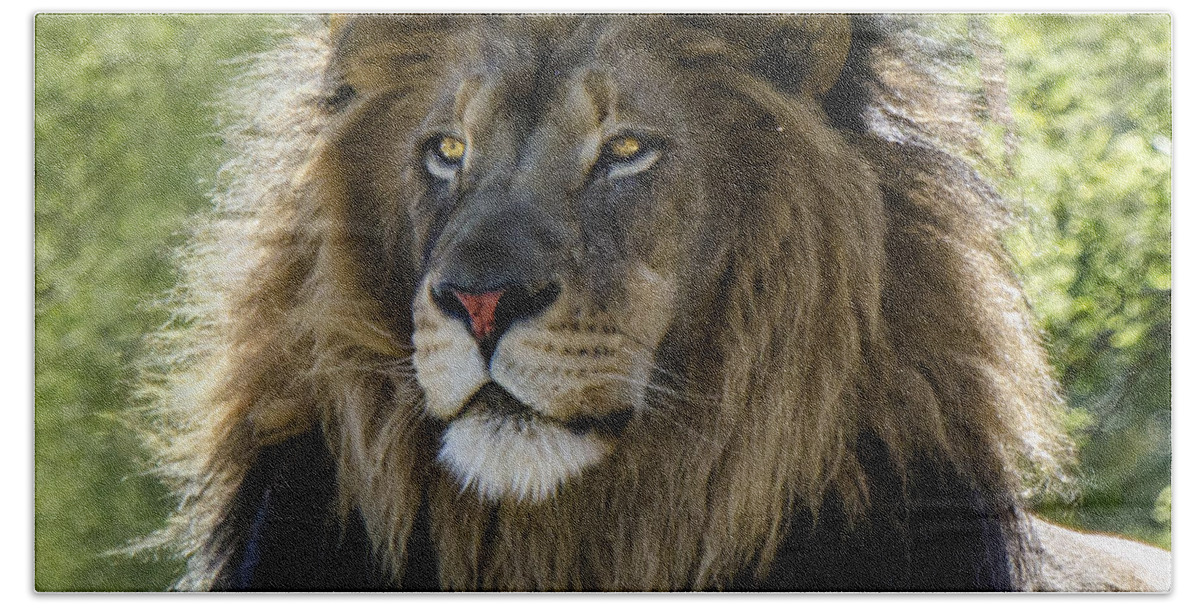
328;17;883;501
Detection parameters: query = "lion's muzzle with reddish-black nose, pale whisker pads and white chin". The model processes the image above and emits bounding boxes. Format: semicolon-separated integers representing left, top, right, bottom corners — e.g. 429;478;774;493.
413;277;631;500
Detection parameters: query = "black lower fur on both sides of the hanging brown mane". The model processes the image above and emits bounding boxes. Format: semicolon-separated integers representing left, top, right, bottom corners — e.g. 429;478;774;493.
214;426;1016;591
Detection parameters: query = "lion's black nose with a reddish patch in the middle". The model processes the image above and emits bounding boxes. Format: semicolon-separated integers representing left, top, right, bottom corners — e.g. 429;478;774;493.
431;282;560;359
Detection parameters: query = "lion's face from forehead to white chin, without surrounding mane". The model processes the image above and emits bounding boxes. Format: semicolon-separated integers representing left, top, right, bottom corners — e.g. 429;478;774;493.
410;61;694;500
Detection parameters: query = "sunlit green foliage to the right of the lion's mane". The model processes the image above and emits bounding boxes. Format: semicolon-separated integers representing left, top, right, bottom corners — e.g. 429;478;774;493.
996;16;1171;546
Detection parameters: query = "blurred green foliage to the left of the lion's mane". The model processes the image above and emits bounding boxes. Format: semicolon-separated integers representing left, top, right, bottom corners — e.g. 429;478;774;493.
34;14;286;590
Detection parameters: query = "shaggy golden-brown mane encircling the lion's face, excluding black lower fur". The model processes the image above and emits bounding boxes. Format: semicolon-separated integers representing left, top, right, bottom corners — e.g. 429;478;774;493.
148;17;1080;589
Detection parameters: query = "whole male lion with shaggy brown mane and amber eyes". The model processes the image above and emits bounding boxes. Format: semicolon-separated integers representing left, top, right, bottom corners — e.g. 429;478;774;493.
138;14;1169;590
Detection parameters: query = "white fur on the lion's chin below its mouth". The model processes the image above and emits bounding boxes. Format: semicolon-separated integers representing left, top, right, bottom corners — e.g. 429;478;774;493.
438;415;608;502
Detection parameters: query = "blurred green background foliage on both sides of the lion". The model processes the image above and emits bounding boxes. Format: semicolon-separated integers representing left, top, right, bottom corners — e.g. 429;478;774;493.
34;16;1171;590
